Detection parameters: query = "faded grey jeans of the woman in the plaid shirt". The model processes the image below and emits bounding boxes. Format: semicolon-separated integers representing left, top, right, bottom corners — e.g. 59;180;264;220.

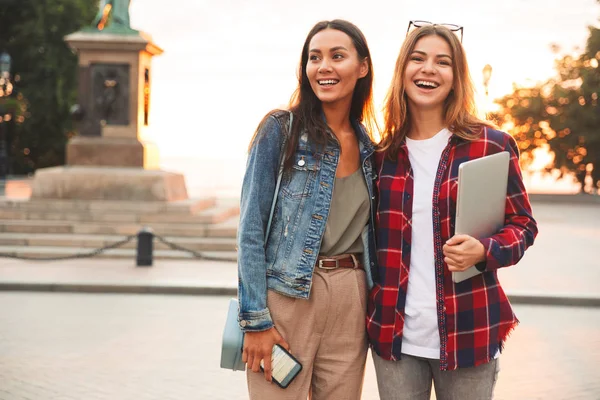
373;353;500;400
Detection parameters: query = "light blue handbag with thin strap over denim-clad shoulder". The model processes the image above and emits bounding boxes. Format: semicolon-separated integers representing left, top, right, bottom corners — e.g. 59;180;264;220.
221;111;294;371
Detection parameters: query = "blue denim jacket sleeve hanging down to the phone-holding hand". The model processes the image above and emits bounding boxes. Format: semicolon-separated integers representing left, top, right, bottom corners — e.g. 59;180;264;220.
237;115;284;331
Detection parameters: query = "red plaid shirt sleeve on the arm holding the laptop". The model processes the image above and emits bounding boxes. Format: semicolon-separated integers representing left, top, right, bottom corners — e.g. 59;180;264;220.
477;134;538;271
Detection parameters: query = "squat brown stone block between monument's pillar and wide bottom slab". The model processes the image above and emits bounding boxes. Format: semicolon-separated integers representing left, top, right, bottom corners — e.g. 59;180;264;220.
66;136;158;169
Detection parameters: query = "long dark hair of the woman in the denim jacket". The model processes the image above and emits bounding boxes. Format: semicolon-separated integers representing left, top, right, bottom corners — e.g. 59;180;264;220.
250;19;376;168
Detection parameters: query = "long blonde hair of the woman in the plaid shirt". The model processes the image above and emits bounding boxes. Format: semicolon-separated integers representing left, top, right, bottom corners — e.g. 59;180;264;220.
379;25;494;160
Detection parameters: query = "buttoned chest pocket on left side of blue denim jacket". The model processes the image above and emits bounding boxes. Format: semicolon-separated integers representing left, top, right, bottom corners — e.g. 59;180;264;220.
281;151;319;200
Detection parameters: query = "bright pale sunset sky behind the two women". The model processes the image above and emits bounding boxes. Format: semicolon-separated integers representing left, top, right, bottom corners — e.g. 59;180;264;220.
124;0;600;194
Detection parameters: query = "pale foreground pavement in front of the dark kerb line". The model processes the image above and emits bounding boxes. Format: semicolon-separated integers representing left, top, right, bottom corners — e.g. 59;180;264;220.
0;292;600;400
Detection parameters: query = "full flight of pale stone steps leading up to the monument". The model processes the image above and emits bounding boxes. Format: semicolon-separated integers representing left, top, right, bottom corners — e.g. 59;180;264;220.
0;197;239;260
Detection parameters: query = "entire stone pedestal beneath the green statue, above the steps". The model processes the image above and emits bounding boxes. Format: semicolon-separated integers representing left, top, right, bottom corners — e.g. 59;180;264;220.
31;29;187;202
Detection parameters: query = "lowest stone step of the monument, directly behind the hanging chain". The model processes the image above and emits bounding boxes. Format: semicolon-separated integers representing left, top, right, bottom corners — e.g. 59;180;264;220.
0;246;237;262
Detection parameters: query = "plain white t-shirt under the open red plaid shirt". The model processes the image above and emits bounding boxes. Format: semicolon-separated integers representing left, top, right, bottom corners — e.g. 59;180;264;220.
402;129;452;359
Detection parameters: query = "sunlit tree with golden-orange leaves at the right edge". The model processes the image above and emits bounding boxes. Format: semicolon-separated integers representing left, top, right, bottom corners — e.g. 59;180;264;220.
495;24;600;191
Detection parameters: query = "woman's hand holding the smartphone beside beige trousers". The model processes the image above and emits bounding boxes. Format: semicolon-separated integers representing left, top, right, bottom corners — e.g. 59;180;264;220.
242;328;290;382
